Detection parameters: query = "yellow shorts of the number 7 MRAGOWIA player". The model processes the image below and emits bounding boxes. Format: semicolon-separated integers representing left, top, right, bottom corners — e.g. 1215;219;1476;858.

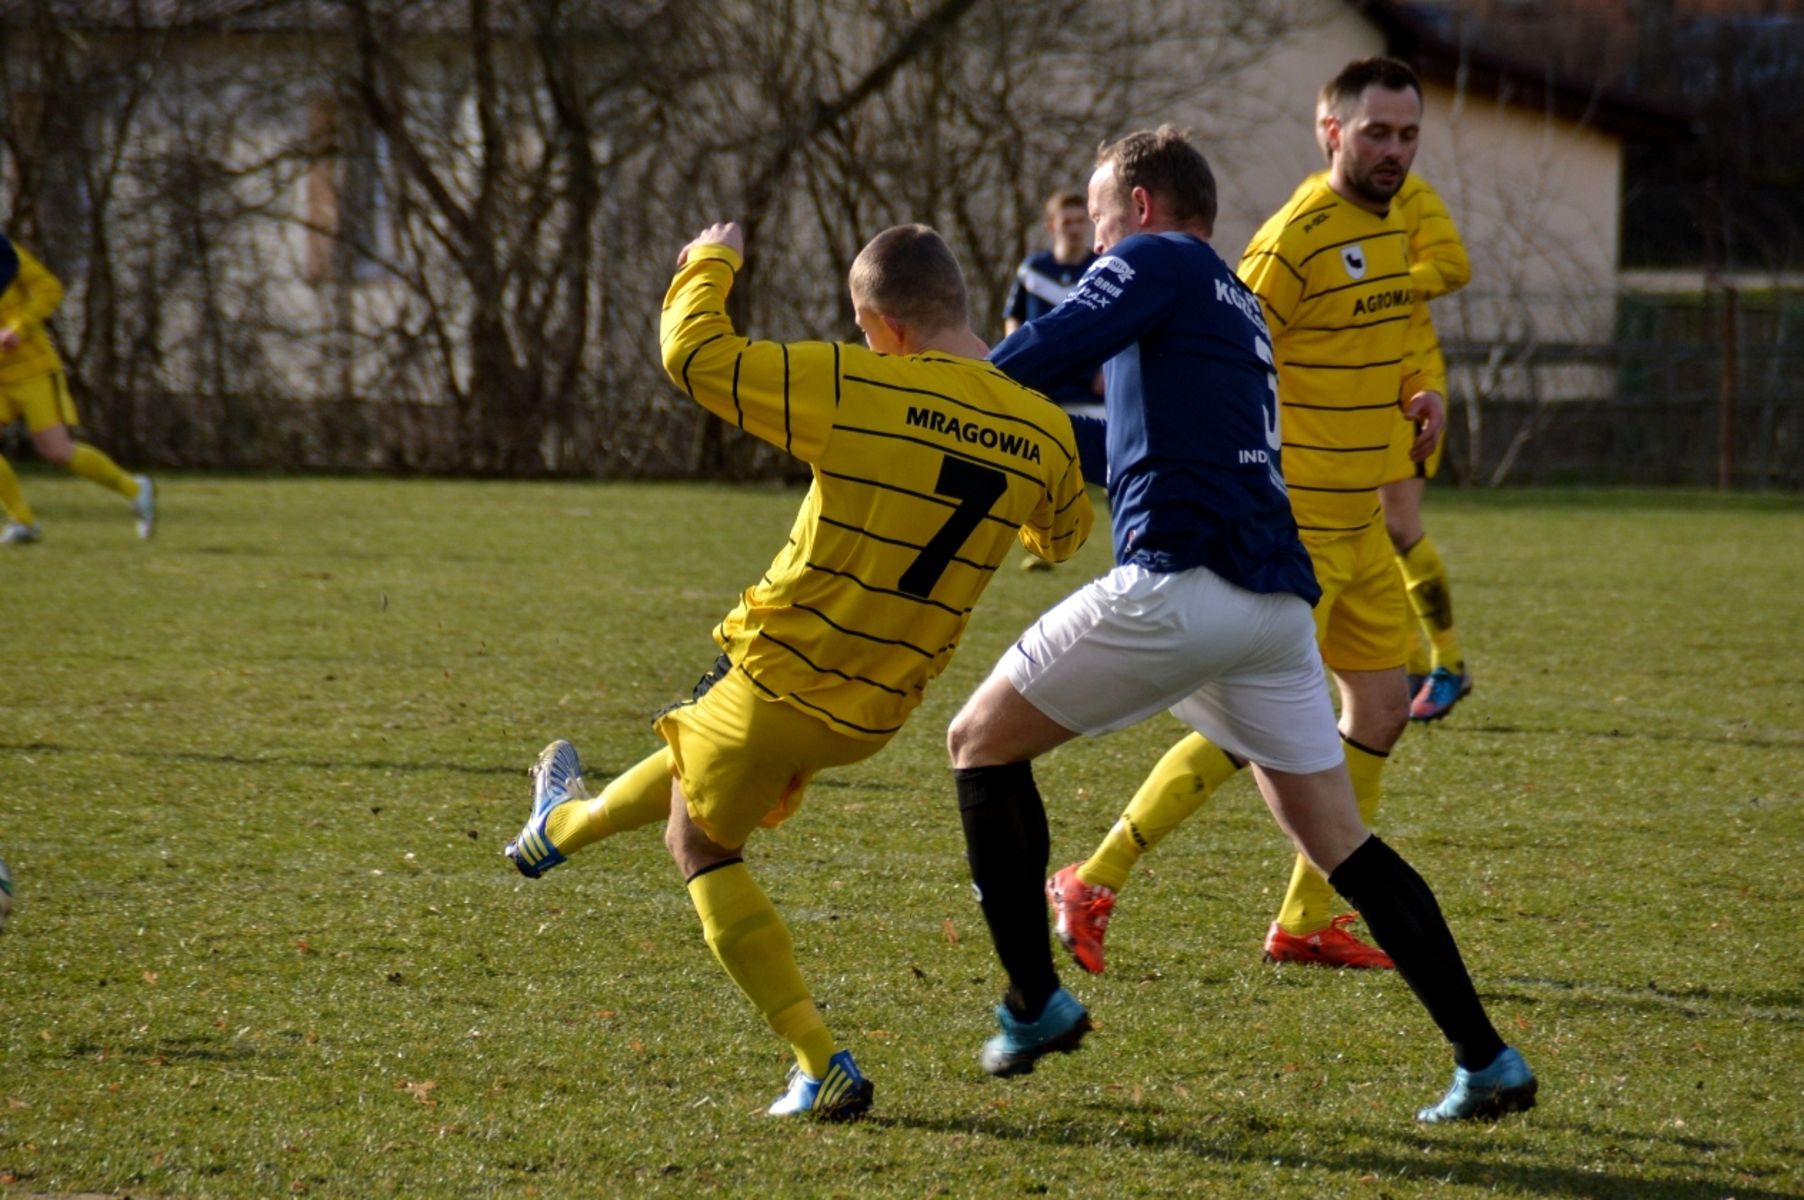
655;664;891;850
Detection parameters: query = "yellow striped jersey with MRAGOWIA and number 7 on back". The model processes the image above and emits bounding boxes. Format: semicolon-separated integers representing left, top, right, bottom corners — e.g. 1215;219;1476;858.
658;245;1093;738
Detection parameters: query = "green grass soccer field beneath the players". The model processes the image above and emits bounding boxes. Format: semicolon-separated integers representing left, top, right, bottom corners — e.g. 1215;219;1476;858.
0;475;1804;1200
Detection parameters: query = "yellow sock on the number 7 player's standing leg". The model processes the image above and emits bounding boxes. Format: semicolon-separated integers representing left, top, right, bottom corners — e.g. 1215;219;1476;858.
689;863;833;1079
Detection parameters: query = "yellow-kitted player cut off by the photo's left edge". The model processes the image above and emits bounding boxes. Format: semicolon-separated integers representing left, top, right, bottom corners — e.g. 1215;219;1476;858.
0;234;157;545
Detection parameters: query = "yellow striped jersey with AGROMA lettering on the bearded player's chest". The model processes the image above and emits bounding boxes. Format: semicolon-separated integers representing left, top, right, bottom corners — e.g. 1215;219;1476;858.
1239;177;1432;540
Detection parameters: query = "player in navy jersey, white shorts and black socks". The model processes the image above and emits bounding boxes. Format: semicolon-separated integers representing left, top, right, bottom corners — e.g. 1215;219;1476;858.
947;126;1535;1122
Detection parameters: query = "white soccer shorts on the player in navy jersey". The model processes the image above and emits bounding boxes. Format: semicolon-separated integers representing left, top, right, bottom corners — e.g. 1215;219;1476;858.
996;567;1344;774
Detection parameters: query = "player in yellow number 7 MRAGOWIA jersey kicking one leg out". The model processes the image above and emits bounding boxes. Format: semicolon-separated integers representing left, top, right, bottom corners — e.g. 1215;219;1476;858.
507;224;1091;1119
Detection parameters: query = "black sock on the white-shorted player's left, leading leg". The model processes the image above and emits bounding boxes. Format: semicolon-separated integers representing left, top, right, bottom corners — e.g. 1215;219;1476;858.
953;763;1059;1021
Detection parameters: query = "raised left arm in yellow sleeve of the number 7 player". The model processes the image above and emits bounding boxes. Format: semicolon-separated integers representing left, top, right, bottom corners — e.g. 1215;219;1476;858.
658;222;839;462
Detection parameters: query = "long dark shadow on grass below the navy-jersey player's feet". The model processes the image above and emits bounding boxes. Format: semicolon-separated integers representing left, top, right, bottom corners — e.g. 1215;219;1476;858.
864;1110;1797;1200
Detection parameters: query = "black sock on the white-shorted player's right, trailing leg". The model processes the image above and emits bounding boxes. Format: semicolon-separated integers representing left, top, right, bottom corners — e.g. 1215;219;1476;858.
1328;834;1503;1070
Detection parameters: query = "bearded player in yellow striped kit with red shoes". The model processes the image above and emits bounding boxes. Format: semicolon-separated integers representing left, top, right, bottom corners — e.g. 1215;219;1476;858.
1046;58;1445;971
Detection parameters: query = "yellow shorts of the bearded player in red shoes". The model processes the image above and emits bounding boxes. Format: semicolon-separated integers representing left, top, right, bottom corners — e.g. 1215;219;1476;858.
1302;522;1416;671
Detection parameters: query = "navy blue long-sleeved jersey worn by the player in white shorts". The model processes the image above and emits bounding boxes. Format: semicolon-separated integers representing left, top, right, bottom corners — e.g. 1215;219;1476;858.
990;233;1321;605
